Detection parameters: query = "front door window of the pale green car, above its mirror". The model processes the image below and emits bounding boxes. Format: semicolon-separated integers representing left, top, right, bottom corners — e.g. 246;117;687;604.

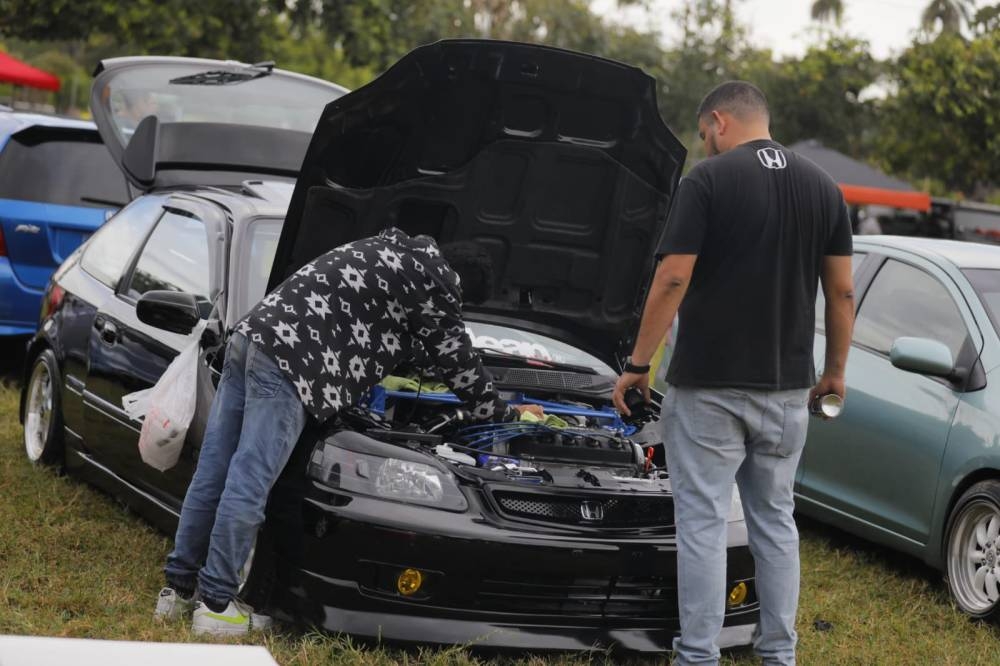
854;259;969;358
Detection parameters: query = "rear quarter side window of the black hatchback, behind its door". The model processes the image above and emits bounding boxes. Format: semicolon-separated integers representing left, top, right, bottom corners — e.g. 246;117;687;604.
80;197;163;289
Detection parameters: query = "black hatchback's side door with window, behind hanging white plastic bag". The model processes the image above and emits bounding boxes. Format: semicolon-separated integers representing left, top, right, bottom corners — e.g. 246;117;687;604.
86;199;221;503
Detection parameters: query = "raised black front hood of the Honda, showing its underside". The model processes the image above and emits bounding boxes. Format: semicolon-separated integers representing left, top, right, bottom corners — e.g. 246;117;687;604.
268;40;686;367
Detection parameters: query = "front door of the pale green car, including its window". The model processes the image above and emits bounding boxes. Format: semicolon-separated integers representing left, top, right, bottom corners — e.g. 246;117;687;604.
798;255;982;545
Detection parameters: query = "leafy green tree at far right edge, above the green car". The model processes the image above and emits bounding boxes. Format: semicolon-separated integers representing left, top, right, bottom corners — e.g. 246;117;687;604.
877;31;1000;198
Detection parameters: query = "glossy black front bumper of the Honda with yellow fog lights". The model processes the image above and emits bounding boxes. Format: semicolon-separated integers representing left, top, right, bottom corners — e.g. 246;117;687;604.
269;486;758;652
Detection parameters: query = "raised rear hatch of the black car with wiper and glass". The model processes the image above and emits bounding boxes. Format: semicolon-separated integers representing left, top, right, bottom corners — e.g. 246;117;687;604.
90;56;347;191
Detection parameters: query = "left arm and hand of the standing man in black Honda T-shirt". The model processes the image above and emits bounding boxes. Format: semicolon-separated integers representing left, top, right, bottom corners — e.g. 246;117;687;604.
612;254;698;415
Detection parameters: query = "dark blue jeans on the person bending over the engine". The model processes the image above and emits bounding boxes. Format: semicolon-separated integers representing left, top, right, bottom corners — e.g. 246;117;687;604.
165;334;306;604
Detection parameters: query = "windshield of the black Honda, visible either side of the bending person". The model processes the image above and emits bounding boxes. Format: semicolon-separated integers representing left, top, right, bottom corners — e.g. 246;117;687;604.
231;227;615;375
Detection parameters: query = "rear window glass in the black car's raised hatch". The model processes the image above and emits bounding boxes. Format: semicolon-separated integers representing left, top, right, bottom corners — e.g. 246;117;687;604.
98;60;346;147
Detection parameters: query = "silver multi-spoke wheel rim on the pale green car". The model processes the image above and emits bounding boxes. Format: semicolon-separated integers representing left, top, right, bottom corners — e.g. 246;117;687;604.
948;499;1000;614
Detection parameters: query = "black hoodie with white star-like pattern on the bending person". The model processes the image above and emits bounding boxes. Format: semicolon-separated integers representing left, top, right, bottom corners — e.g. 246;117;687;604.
235;228;517;422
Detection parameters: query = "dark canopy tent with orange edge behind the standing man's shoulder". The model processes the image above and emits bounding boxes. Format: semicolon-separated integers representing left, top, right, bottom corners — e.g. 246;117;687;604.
789;139;931;213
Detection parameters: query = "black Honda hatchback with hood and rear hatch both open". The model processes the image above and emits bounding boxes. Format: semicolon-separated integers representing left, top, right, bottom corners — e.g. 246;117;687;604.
22;41;758;651
